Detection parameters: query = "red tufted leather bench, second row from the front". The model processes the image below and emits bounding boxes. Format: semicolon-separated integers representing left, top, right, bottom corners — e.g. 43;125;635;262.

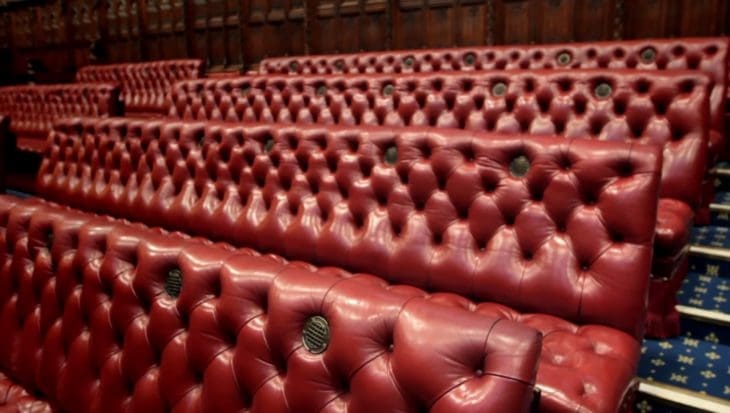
38;119;661;412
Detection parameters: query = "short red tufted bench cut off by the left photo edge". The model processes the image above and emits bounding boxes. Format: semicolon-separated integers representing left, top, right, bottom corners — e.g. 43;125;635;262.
0;84;119;152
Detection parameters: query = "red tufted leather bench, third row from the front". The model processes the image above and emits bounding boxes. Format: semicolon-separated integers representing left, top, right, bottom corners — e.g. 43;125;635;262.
169;70;711;337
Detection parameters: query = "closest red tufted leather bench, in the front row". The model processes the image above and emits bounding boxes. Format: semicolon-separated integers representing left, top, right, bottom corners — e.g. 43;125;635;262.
0;196;541;413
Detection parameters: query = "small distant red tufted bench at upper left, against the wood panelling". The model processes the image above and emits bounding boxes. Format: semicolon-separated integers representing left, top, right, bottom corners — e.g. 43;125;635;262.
76;59;204;116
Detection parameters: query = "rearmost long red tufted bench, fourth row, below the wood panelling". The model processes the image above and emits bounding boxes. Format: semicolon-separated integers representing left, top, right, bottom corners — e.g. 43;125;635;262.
259;37;730;163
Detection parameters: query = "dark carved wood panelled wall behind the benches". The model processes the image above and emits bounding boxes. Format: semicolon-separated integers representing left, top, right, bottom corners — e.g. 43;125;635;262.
0;0;730;83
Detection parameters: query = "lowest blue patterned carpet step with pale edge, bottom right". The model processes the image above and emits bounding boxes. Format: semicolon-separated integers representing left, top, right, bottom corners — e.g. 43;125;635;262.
639;332;730;402
